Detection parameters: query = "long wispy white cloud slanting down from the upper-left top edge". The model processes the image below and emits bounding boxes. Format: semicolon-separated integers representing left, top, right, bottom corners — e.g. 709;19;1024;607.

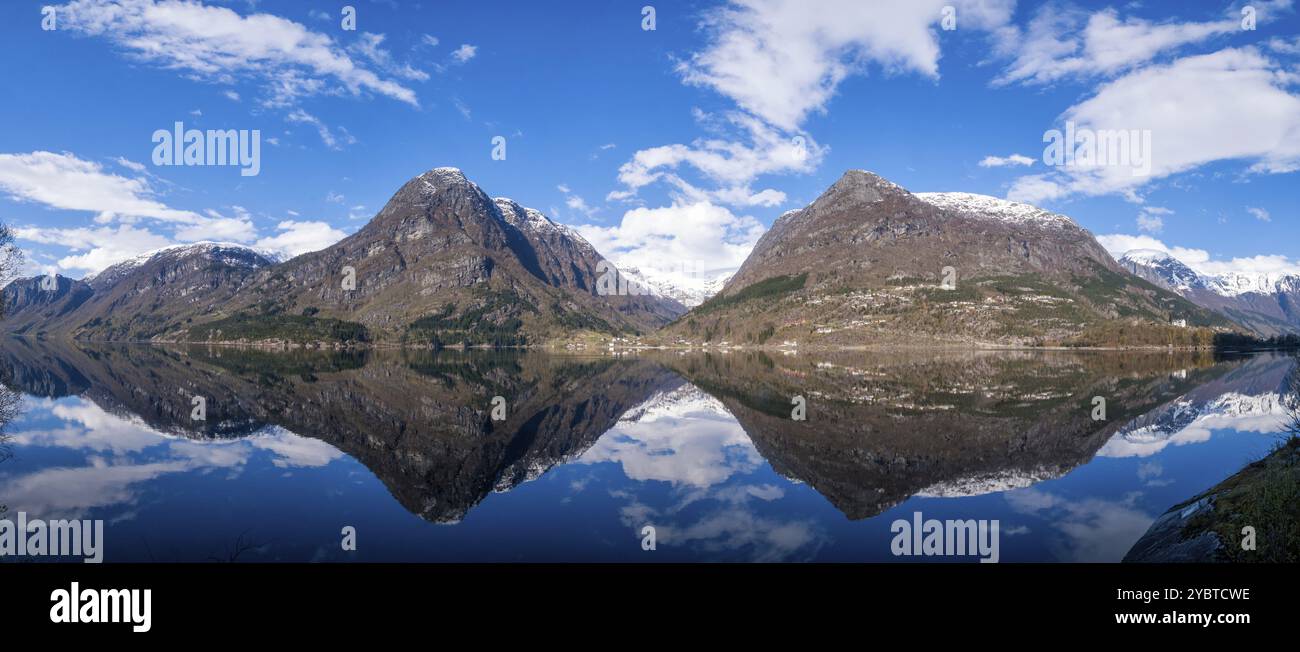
59;0;419;107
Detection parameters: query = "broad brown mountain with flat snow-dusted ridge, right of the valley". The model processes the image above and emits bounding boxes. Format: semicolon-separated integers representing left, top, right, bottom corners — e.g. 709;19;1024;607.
666;170;1234;345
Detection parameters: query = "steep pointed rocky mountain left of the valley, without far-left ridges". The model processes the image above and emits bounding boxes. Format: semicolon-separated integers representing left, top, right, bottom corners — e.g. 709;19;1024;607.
186;168;683;344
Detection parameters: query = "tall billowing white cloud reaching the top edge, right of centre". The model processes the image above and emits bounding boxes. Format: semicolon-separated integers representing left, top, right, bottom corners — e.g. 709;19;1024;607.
607;0;1014;207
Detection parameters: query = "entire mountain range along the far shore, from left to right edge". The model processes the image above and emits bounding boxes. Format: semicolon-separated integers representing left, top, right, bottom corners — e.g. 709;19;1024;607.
0;168;1300;349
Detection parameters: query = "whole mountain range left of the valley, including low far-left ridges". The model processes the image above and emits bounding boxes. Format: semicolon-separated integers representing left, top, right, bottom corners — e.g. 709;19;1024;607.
5;168;685;344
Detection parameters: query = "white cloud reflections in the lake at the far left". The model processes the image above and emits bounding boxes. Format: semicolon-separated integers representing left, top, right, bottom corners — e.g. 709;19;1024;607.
0;399;342;518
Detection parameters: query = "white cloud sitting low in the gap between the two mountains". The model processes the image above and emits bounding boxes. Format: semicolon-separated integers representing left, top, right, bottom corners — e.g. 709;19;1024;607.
577;201;764;281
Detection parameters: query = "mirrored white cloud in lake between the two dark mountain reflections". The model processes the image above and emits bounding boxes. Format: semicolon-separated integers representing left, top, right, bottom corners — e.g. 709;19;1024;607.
579;384;826;561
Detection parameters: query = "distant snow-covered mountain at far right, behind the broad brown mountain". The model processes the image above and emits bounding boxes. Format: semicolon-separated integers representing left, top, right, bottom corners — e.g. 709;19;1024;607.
1119;249;1300;335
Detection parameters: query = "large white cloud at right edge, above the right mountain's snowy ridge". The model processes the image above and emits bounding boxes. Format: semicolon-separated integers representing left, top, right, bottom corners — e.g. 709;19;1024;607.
1008;48;1300;203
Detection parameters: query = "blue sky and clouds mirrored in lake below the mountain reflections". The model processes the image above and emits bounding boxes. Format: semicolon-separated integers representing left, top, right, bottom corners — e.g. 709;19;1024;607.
0;358;1283;561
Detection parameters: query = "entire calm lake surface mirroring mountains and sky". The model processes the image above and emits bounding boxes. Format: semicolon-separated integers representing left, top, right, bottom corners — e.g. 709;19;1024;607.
0;340;1297;562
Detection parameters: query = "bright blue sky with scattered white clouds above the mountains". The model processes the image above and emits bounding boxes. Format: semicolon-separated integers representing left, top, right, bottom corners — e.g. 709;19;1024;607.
0;0;1300;283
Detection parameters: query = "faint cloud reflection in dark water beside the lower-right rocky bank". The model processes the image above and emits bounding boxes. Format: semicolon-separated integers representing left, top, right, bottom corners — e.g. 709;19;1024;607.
1005;488;1156;561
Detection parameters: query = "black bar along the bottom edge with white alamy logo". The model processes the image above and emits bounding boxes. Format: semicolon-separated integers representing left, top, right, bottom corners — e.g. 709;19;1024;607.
0;564;1297;643
